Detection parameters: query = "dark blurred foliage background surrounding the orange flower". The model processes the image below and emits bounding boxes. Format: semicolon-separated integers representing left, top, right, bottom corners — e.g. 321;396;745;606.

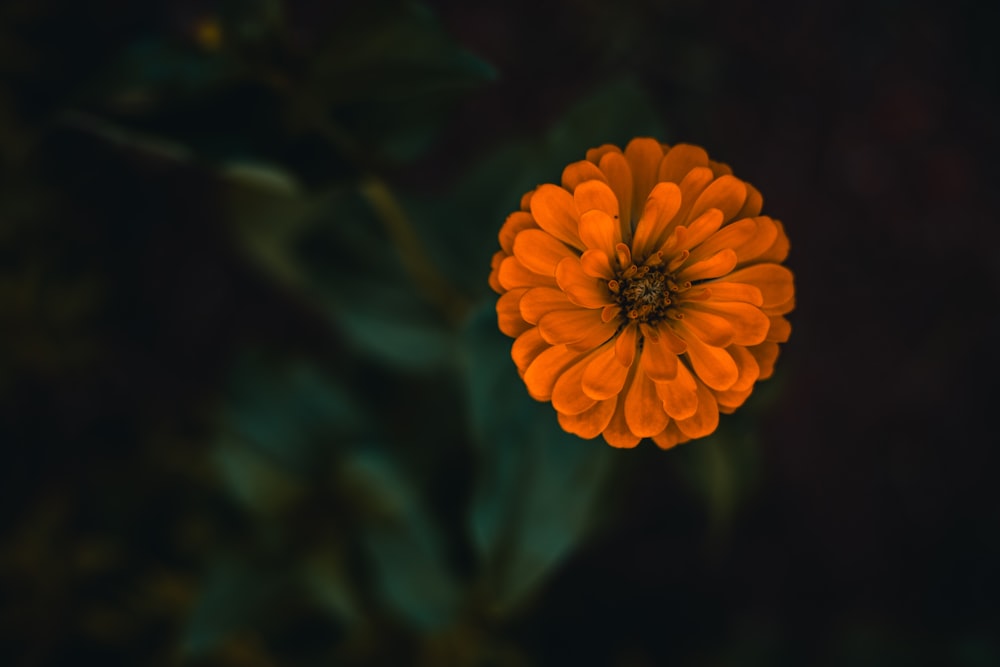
0;0;1000;667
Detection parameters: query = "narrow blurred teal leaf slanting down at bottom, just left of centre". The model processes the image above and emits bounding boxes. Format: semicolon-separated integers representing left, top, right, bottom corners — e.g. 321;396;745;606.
341;448;460;630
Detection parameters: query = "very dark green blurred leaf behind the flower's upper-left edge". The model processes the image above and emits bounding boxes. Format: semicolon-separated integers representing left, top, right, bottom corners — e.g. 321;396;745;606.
407;78;664;294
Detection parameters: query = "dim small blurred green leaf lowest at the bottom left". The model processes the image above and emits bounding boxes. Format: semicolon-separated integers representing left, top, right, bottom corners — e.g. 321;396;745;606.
181;559;284;657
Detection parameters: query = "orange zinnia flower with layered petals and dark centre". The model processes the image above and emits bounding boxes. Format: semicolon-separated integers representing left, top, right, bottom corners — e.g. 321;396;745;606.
490;138;795;449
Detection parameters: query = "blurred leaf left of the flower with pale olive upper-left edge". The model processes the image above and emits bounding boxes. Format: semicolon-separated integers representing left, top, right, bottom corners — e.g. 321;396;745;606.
229;180;454;371
